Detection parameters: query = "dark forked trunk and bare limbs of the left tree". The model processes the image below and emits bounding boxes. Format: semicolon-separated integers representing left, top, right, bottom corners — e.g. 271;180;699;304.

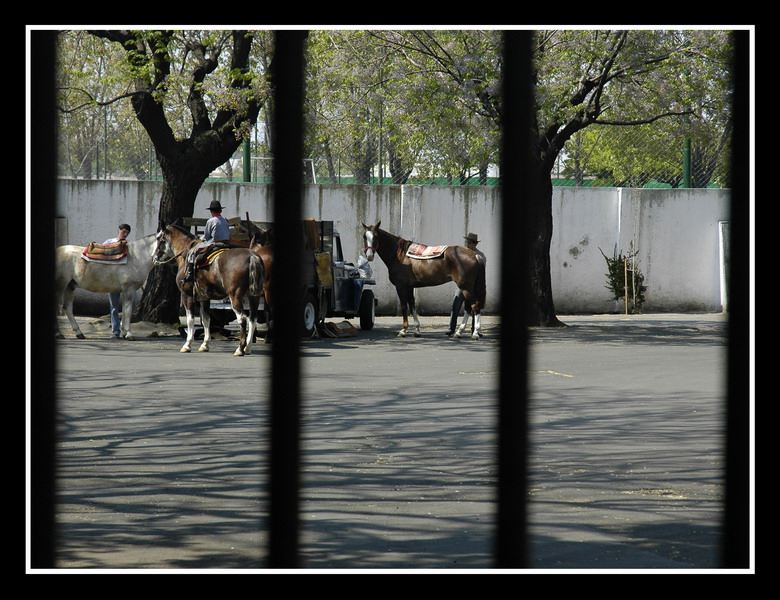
87;30;266;323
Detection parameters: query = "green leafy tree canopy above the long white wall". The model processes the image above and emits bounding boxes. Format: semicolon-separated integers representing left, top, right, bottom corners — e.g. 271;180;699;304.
59;29;731;187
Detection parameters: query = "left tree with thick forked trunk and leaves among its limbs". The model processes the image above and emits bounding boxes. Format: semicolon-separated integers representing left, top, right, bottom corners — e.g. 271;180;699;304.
91;30;268;322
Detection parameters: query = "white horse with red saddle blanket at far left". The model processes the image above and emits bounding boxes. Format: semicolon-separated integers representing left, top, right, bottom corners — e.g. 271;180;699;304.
54;234;157;340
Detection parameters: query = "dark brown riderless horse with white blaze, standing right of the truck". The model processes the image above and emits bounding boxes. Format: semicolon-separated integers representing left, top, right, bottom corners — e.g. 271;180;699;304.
363;221;486;339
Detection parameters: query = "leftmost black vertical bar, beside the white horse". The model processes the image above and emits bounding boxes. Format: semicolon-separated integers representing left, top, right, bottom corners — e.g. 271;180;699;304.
28;31;57;569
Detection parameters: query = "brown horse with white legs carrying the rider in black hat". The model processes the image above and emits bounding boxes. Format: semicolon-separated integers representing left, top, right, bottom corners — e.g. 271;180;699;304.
154;225;265;356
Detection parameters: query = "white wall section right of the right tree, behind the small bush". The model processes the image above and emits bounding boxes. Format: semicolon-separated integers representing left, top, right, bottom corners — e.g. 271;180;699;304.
550;188;730;314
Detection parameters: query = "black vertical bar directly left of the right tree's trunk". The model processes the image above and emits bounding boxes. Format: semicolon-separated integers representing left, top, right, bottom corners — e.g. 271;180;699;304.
495;31;532;568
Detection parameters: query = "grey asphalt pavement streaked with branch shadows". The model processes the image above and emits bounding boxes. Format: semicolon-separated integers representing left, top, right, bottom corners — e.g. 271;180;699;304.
42;314;727;573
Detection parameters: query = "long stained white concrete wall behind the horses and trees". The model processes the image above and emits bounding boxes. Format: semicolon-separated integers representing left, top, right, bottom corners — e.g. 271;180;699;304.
57;180;729;314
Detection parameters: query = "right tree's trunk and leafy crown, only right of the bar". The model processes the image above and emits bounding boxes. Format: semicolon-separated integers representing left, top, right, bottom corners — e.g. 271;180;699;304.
510;30;728;326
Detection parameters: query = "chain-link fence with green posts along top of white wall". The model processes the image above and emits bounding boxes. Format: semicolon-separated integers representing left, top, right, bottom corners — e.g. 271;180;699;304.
59;115;729;188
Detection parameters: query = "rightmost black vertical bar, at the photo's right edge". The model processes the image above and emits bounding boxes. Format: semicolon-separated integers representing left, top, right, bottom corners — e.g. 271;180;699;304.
721;30;751;569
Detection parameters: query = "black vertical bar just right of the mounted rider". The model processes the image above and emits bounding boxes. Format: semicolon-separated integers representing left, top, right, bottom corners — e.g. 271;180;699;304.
268;31;305;568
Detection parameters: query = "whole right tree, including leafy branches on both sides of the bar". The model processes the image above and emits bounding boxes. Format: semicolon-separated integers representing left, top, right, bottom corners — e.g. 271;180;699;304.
366;30;728;326
